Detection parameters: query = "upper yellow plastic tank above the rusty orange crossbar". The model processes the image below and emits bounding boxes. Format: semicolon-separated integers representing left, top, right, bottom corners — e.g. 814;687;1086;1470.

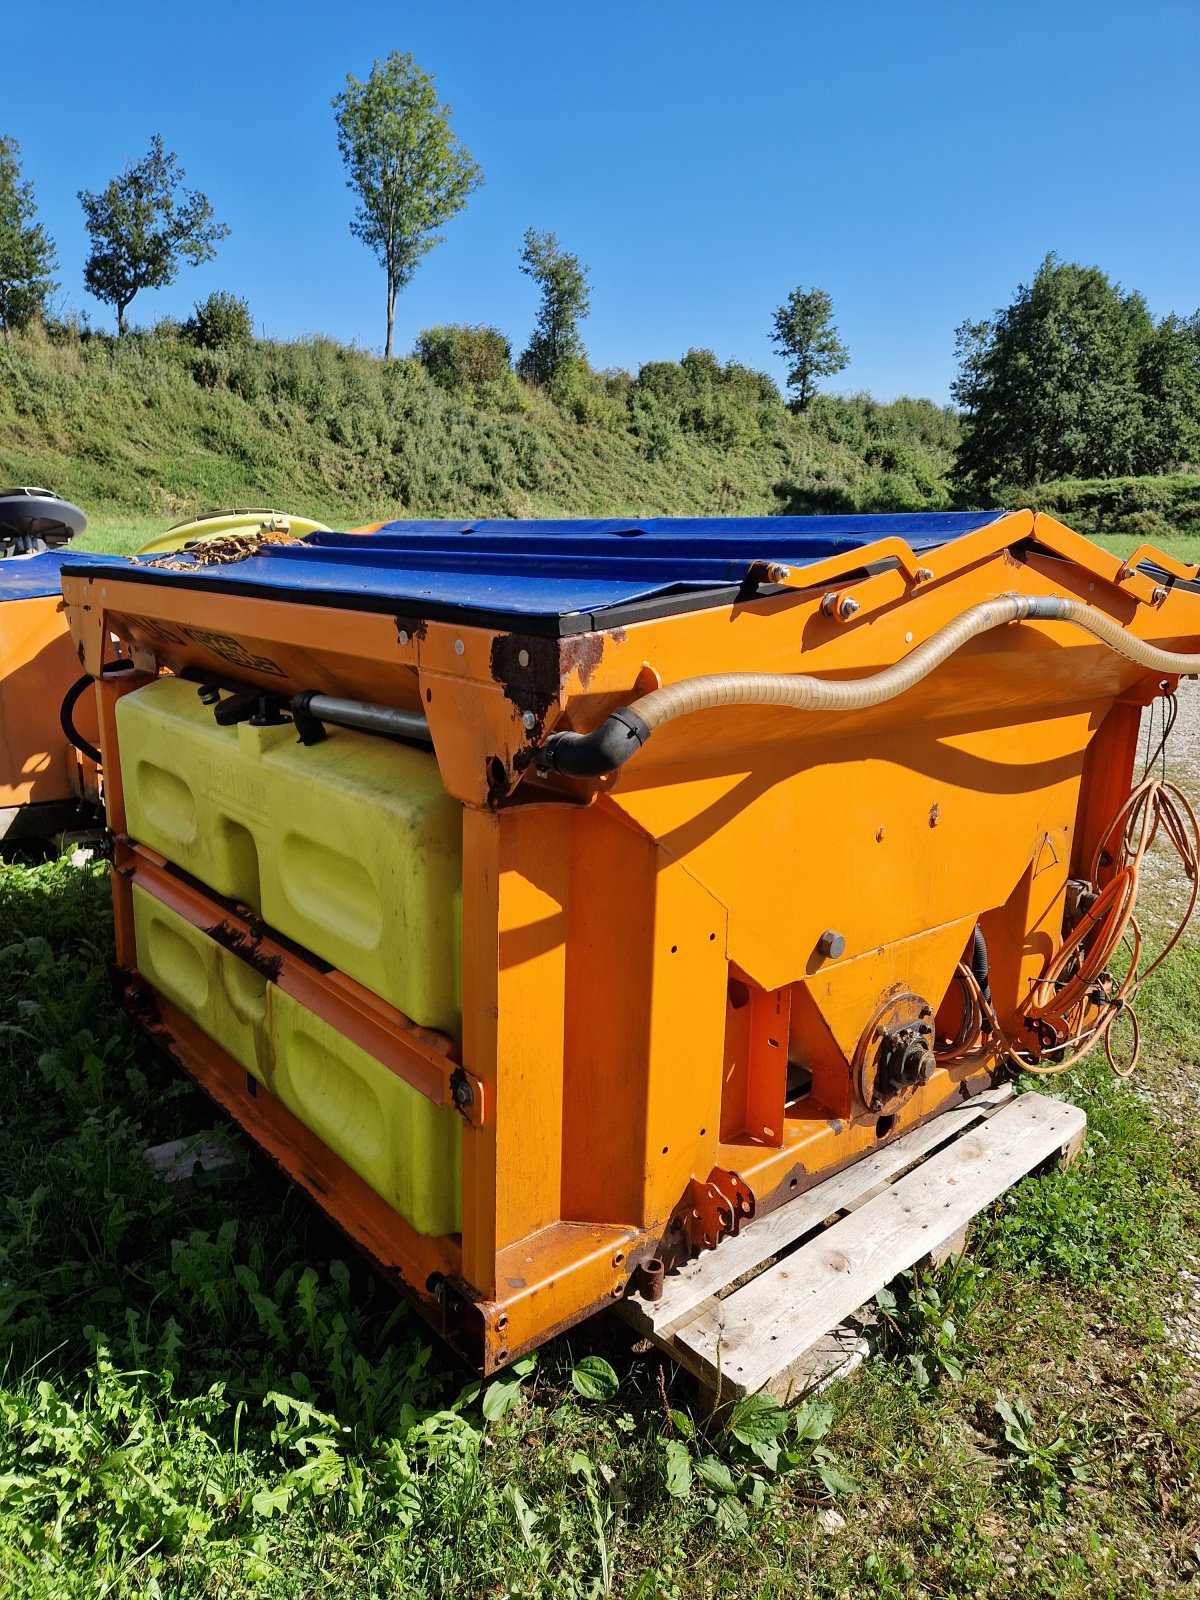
117;677;462;1038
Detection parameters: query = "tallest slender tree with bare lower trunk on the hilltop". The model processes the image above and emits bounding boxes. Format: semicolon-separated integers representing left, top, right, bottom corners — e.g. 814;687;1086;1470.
333;50;483;358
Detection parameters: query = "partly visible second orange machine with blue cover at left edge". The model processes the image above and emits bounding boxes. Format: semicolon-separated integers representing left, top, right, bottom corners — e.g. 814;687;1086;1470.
0;488;99;842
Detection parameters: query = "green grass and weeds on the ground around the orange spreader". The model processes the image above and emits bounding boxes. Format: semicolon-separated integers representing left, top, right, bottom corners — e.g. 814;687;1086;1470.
0;862;1200;1600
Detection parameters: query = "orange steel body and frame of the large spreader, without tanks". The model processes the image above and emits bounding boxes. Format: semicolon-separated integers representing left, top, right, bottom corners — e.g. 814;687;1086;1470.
64;512;1200;1371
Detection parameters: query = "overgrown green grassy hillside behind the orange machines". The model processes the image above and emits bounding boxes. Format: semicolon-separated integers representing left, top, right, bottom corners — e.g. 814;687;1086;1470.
0;323;1200;560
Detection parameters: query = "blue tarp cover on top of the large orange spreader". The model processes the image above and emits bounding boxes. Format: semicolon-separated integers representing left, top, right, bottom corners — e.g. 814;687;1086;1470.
58;512;1005;630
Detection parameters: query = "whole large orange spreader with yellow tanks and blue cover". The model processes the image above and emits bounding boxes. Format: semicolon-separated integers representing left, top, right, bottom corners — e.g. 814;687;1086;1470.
62;512;1200;1371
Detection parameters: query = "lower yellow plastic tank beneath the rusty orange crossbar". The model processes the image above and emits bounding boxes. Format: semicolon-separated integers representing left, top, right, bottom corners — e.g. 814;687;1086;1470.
133;885;462;1234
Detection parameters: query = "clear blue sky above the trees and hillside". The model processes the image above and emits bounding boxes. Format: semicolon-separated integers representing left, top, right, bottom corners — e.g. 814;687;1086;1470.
9;0;1200;402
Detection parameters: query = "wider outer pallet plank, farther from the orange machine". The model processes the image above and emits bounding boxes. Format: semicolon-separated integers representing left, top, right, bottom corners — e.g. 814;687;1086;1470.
675;1094;1086;1395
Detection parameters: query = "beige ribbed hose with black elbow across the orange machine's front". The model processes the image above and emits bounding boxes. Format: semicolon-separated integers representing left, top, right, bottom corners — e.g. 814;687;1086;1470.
539;595;1200;778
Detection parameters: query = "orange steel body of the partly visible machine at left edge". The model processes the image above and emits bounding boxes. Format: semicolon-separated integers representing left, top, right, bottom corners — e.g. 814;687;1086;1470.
0;595;98;814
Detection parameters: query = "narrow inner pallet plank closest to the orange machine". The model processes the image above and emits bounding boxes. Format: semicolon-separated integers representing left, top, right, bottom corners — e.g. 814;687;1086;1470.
621;1083;1013;1338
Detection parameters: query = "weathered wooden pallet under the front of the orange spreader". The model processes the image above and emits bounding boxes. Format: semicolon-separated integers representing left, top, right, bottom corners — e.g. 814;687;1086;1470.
621;1085;1086;1403
